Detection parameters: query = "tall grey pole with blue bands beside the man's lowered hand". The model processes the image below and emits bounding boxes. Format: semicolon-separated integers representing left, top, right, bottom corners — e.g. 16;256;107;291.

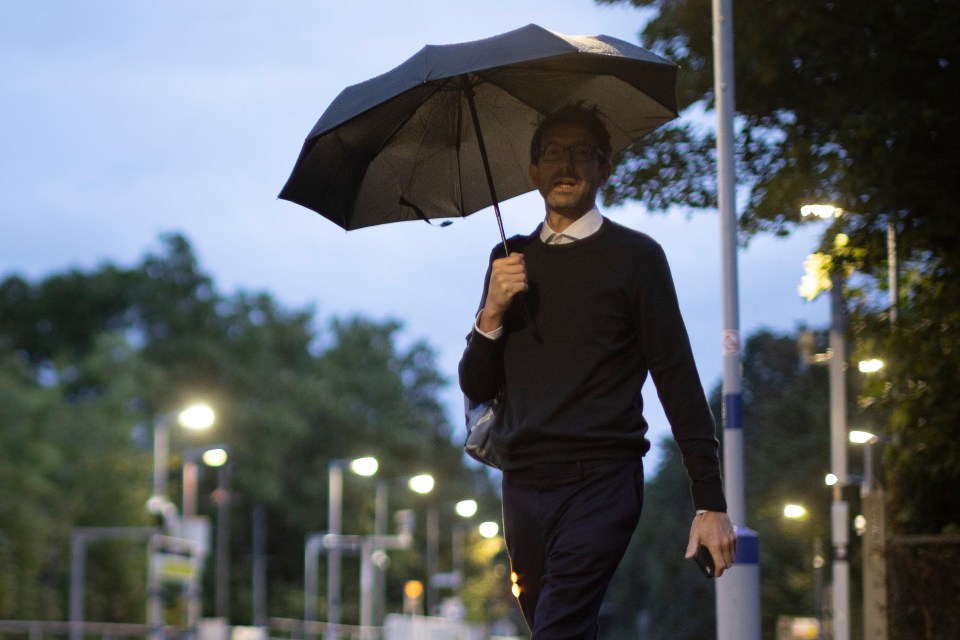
712;0;760;640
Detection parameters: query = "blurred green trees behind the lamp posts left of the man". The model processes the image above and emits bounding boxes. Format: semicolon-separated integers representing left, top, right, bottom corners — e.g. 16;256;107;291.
0;235;495;623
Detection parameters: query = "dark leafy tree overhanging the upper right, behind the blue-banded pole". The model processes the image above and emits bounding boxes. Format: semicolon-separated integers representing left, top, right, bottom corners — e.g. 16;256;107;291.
597;0;960;533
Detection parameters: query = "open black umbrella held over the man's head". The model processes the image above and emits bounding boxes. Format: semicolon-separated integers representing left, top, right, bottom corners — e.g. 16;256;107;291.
280;24;677;252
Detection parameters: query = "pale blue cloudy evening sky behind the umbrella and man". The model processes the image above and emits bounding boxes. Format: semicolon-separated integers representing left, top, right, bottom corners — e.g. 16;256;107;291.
0;0;828;468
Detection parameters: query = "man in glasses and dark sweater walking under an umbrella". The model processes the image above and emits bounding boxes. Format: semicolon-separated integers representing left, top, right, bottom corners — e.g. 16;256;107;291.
460;104;736;640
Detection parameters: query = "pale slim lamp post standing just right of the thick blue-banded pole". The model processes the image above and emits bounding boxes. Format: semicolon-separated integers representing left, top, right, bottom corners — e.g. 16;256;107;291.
828;272;850;640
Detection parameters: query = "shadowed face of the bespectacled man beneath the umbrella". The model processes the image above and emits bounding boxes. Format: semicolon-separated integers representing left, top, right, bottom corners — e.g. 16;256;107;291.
530;124;611;220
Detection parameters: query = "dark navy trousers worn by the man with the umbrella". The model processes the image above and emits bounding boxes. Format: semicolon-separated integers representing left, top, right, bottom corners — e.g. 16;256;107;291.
503;458;643;640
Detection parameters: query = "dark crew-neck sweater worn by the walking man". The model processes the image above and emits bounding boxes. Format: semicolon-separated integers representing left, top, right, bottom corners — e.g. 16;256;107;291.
460;218;726;511
